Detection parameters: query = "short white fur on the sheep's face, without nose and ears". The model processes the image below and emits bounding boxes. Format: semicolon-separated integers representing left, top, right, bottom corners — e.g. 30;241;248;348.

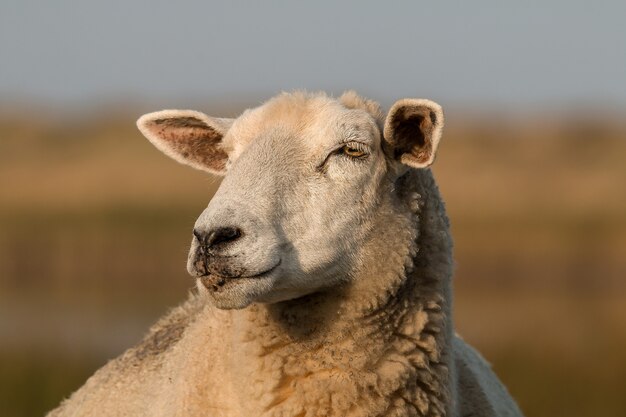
190;96;386;308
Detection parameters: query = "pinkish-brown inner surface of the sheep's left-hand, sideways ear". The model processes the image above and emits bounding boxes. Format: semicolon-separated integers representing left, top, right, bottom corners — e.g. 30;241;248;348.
147;116;228;172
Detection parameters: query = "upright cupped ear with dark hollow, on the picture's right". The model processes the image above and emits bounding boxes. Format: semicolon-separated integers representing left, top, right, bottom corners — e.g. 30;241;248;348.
383;98;443;168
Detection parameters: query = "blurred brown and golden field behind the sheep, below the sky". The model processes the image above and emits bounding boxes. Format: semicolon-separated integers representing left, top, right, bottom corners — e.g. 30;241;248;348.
0;105;626;417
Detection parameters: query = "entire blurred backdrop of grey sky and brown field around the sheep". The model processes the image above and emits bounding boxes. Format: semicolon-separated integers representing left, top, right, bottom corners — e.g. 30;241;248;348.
0;0;626;417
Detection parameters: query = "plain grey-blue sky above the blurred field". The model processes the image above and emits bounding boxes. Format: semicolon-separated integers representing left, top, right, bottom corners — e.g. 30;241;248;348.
0;0;626;106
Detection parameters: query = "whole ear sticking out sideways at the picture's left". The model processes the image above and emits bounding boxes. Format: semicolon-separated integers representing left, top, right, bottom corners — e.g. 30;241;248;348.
137;110;233;175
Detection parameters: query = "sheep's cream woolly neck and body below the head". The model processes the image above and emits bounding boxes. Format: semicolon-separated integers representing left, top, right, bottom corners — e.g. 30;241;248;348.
49;170;521;417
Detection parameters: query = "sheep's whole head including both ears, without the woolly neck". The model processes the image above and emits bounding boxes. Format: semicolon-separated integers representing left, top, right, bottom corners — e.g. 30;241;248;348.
138;93;443;308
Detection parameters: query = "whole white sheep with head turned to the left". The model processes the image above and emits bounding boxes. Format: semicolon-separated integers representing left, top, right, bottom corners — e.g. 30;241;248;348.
49;92;521;417
